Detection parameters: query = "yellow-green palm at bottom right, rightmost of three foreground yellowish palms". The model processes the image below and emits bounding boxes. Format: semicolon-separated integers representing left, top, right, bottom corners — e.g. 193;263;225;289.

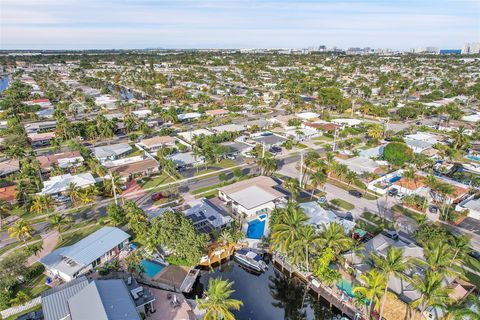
410;270;451;319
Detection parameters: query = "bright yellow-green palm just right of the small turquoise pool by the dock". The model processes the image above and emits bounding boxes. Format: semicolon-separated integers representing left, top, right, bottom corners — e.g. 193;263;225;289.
352;269;386;319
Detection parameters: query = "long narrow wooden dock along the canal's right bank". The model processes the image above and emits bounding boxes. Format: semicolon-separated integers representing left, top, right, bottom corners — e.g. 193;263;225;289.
272;255;367;320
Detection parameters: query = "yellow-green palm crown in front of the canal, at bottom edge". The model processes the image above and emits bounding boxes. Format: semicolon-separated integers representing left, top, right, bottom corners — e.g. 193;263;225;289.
197;278;243;320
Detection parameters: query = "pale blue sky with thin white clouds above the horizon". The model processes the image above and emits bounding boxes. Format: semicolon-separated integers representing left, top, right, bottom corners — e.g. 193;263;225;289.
0;0;480;50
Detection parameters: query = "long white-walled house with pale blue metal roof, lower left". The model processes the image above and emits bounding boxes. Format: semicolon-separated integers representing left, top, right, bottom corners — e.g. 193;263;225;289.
39;227;130;282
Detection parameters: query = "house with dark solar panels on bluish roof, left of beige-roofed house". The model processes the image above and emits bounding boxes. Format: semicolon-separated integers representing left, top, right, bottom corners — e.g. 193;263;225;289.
183;198;233;233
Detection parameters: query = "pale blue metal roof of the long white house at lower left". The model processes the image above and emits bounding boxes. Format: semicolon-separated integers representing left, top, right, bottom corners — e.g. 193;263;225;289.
62;227;130;265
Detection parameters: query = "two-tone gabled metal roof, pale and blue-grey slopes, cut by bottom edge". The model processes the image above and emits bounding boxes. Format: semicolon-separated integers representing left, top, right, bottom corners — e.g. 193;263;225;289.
68;279;140;320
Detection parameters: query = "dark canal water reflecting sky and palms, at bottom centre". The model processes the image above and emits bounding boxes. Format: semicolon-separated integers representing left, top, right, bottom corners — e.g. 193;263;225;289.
188;260;340;320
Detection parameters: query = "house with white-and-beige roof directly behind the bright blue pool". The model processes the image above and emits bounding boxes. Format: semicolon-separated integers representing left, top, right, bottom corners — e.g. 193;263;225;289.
218;176;287;217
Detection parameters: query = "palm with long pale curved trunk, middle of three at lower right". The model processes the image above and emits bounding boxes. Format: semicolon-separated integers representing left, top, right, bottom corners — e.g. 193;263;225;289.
371;246;410;319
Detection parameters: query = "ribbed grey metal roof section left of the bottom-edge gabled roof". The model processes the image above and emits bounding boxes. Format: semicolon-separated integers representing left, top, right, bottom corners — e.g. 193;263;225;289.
42;277;88;320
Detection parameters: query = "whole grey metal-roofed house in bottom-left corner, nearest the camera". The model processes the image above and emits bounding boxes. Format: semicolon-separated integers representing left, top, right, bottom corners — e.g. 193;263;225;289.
41;277;155;320
